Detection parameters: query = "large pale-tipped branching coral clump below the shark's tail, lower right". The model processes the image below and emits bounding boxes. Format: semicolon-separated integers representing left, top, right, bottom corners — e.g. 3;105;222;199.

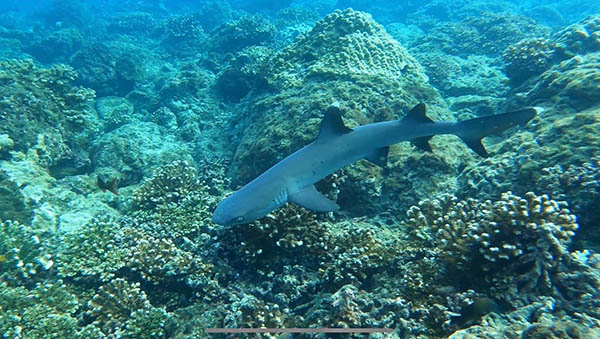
409;192;600;314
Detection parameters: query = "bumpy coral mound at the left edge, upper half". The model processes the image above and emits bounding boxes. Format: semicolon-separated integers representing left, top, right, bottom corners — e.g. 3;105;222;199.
0;60;98;170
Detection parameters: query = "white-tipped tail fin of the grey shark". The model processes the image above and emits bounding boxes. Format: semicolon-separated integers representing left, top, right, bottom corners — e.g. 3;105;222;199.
456;107;544;158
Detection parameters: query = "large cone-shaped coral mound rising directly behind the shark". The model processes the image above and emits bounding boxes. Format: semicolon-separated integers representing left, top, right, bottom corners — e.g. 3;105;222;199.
230;9;441;193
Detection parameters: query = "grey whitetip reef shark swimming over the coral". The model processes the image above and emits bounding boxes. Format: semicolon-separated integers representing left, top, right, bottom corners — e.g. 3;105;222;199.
212;102;543;225
